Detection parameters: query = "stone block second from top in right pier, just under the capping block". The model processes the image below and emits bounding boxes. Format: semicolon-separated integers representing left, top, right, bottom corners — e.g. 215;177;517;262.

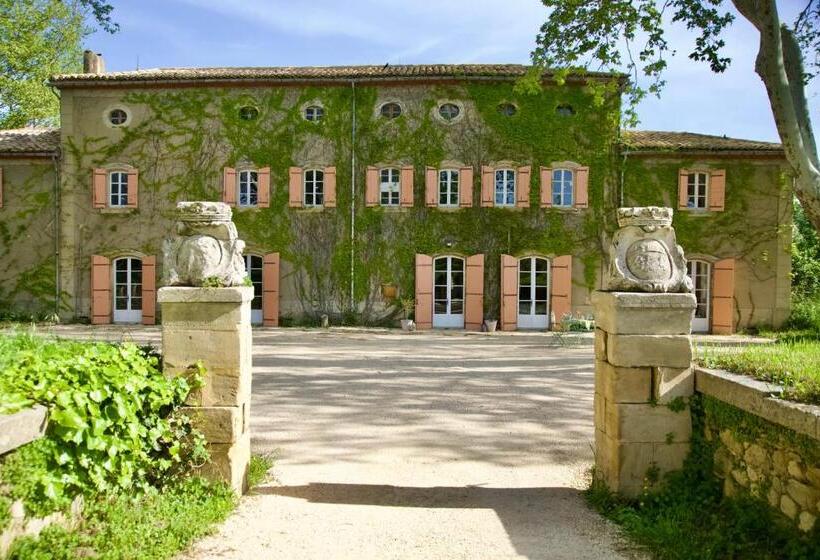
606;334;692;368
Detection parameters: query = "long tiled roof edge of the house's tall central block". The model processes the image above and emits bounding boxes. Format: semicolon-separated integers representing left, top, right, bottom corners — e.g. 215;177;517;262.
51;64;621;86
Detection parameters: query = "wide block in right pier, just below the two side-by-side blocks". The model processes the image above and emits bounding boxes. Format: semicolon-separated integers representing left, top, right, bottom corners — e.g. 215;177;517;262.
605;401;692;443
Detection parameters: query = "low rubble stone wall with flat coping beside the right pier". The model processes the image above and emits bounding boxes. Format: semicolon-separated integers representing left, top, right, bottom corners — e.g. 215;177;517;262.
695;368;820;531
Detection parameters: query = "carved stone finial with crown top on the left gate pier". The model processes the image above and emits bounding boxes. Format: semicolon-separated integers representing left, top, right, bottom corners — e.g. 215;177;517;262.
162;202;246;286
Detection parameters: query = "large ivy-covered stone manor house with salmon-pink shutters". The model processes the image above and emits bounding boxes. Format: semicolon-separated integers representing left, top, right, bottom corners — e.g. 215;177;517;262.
0;52;792;333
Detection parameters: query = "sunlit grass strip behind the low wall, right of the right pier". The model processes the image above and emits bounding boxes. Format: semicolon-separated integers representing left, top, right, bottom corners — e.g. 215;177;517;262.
697;331;820;404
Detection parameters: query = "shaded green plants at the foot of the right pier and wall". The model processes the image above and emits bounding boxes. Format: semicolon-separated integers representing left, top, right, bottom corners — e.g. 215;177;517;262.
586;398;820;560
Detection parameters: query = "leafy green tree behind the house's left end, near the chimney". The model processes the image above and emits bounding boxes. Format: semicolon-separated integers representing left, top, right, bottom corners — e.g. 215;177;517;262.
0;0;118;128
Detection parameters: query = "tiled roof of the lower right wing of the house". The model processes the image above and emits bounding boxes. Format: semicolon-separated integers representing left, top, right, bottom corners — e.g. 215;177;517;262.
621;130;783;152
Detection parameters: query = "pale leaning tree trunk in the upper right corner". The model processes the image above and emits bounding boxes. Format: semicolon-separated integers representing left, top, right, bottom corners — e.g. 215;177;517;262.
732;0;820;231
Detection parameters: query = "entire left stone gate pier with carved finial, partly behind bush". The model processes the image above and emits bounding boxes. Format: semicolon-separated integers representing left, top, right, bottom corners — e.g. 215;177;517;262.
157;202;253;494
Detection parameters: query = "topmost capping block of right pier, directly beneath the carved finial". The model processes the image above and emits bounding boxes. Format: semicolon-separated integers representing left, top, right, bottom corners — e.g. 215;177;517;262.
592;292;696;335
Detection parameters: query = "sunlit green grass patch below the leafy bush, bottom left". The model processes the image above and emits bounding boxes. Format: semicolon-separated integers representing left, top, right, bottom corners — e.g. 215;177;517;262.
8;477;236;560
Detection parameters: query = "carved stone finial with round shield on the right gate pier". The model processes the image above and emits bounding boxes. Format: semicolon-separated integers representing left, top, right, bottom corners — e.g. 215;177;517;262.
605;206;692;293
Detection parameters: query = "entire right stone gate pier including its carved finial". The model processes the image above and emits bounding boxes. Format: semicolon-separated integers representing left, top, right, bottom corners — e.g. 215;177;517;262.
592;207;696;496
